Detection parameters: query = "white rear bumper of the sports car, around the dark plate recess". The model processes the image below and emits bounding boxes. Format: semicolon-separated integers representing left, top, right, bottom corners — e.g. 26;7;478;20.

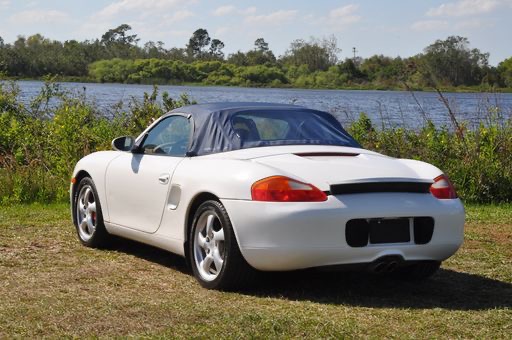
222;193;464;271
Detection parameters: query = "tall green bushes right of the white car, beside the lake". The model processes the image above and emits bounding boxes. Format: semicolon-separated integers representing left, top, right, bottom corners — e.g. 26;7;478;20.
348;114;512;203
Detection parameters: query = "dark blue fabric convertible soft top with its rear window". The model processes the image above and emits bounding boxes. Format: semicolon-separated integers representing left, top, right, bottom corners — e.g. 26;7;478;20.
170;102;361;156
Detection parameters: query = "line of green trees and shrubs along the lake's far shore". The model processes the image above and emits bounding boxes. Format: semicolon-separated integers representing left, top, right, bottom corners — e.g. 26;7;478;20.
0;24;512;89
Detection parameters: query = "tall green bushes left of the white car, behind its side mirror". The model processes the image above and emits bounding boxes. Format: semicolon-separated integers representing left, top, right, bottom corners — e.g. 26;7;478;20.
0;83;191;204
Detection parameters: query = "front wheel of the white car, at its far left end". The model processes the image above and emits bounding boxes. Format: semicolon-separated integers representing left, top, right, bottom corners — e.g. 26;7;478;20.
73;177;110;248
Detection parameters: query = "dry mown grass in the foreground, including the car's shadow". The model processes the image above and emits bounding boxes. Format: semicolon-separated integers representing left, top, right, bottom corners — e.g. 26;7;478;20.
0;204;512;338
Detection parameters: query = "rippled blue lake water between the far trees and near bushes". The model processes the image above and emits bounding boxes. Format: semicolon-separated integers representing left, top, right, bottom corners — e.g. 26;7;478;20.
13;81;512;127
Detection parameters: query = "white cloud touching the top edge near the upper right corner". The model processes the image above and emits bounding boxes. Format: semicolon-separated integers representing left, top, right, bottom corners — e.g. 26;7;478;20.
427;0;502;17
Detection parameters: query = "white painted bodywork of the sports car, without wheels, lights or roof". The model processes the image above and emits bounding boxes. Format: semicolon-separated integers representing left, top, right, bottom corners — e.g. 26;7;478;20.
73;135;464;271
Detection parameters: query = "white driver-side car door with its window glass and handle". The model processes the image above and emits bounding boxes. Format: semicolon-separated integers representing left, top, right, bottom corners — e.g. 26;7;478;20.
106;115;191;233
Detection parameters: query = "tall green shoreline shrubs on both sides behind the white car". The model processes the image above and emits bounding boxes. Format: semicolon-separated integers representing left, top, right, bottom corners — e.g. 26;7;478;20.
0;82;512;205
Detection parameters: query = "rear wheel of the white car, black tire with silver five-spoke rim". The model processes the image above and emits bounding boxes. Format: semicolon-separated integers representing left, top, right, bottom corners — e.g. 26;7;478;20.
188;200;256;290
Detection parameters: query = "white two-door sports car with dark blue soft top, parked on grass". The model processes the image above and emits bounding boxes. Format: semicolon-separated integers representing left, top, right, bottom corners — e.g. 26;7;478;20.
70;103;464;289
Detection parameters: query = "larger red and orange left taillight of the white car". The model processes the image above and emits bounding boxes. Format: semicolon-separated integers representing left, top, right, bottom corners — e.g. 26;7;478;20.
251;176;327;202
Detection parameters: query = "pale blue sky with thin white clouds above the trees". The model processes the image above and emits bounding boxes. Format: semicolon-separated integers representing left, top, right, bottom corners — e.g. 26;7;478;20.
0;0;512;65
